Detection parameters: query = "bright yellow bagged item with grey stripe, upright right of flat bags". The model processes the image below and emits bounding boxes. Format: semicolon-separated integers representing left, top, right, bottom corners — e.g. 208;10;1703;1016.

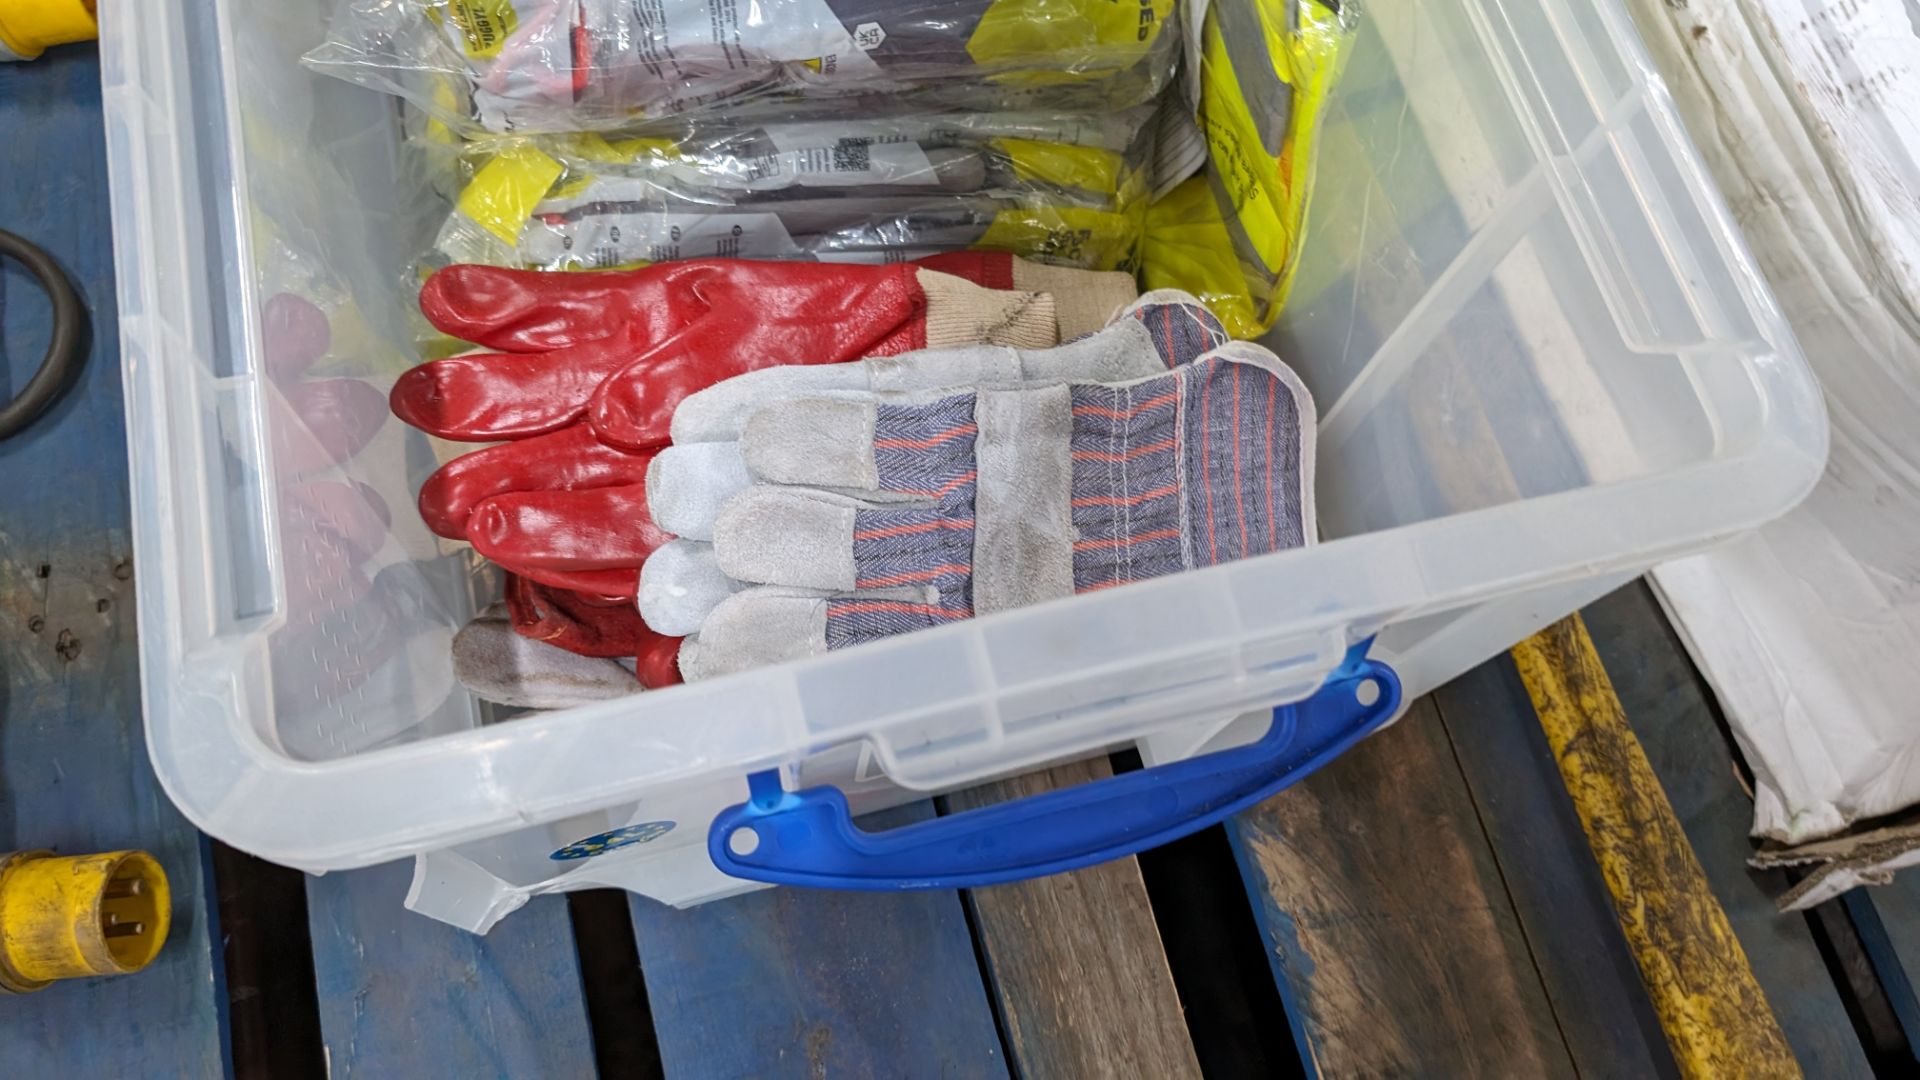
1142;0;1359;338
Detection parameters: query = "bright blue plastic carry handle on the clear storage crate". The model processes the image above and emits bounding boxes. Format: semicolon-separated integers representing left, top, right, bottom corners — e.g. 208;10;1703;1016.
707;638;1400;890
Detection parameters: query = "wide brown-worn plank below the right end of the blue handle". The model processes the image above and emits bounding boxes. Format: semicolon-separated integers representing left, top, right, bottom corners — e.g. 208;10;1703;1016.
1227;698;1576;1076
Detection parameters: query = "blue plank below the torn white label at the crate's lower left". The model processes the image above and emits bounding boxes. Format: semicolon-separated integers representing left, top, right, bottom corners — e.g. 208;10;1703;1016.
307;861;593;1078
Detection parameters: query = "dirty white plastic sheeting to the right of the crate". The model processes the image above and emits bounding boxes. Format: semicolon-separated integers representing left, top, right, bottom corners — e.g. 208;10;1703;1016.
1628;0;1920;907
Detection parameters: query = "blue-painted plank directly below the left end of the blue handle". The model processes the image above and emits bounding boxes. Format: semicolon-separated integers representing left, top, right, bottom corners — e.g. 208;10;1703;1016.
634;803;1006;1080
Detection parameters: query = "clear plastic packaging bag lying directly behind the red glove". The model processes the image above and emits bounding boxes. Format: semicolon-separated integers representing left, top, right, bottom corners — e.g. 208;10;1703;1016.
420;106;1152;271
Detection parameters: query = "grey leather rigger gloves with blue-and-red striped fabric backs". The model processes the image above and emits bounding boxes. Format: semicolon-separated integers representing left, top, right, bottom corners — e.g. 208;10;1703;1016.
641;286;1313;678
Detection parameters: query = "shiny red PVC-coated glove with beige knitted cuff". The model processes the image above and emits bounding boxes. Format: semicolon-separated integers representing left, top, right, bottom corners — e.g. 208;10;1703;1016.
392;259;1056;598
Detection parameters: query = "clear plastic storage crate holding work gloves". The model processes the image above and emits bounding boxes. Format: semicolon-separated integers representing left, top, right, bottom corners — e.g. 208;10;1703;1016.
102;0;1826;928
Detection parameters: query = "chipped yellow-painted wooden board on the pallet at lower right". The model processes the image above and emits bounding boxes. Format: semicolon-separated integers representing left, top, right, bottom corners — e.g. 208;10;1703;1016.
1513;615;1801;1076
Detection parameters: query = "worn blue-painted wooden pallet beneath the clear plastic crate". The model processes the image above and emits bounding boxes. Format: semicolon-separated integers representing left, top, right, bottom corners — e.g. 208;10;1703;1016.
0;42;1920;1076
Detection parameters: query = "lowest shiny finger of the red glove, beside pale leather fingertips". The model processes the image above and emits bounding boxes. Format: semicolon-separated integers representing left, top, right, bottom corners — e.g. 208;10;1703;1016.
467;484;672;580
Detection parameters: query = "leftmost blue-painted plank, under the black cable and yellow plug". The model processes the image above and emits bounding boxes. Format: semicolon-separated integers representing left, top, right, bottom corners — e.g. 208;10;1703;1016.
0;46;227;1078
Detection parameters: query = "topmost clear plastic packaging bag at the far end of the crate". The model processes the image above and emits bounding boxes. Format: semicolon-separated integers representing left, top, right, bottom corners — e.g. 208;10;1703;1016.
307;0;1179;133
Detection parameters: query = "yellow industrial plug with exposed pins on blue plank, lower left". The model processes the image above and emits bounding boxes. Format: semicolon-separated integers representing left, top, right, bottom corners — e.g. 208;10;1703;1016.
0;851;173;994
